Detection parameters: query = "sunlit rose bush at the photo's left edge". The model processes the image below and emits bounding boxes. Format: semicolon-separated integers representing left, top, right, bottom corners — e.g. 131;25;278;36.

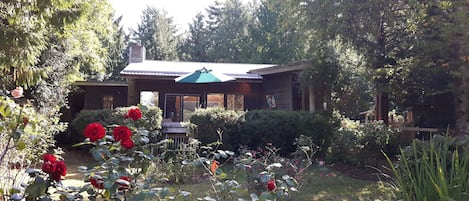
0;87;66;200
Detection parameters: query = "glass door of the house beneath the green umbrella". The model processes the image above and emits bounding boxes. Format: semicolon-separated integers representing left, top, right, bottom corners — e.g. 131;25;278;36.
164;94;200;122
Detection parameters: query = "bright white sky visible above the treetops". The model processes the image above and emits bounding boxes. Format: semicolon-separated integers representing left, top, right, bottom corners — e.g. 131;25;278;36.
110;0;248;32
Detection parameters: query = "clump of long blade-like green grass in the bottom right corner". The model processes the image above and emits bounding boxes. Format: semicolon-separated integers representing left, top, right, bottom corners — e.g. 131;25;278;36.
386;135;469;201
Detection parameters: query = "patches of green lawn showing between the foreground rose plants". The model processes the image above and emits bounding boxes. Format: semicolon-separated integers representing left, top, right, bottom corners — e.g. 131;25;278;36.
63;151;392;201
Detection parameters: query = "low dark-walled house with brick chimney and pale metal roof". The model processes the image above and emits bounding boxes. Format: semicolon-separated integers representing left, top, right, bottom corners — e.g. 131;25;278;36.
77;44;323;122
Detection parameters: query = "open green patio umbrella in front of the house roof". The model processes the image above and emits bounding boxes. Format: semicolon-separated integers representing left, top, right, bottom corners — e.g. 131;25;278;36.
174;67;235;83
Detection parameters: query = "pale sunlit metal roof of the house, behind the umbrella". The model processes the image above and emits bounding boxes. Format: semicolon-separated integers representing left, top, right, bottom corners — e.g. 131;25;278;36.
120;60;277;80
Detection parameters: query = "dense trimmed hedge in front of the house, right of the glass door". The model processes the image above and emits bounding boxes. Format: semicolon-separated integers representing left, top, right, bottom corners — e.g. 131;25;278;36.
191;108;332;155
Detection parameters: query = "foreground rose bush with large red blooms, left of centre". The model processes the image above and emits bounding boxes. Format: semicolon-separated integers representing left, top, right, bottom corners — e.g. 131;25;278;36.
76;107;168;200
